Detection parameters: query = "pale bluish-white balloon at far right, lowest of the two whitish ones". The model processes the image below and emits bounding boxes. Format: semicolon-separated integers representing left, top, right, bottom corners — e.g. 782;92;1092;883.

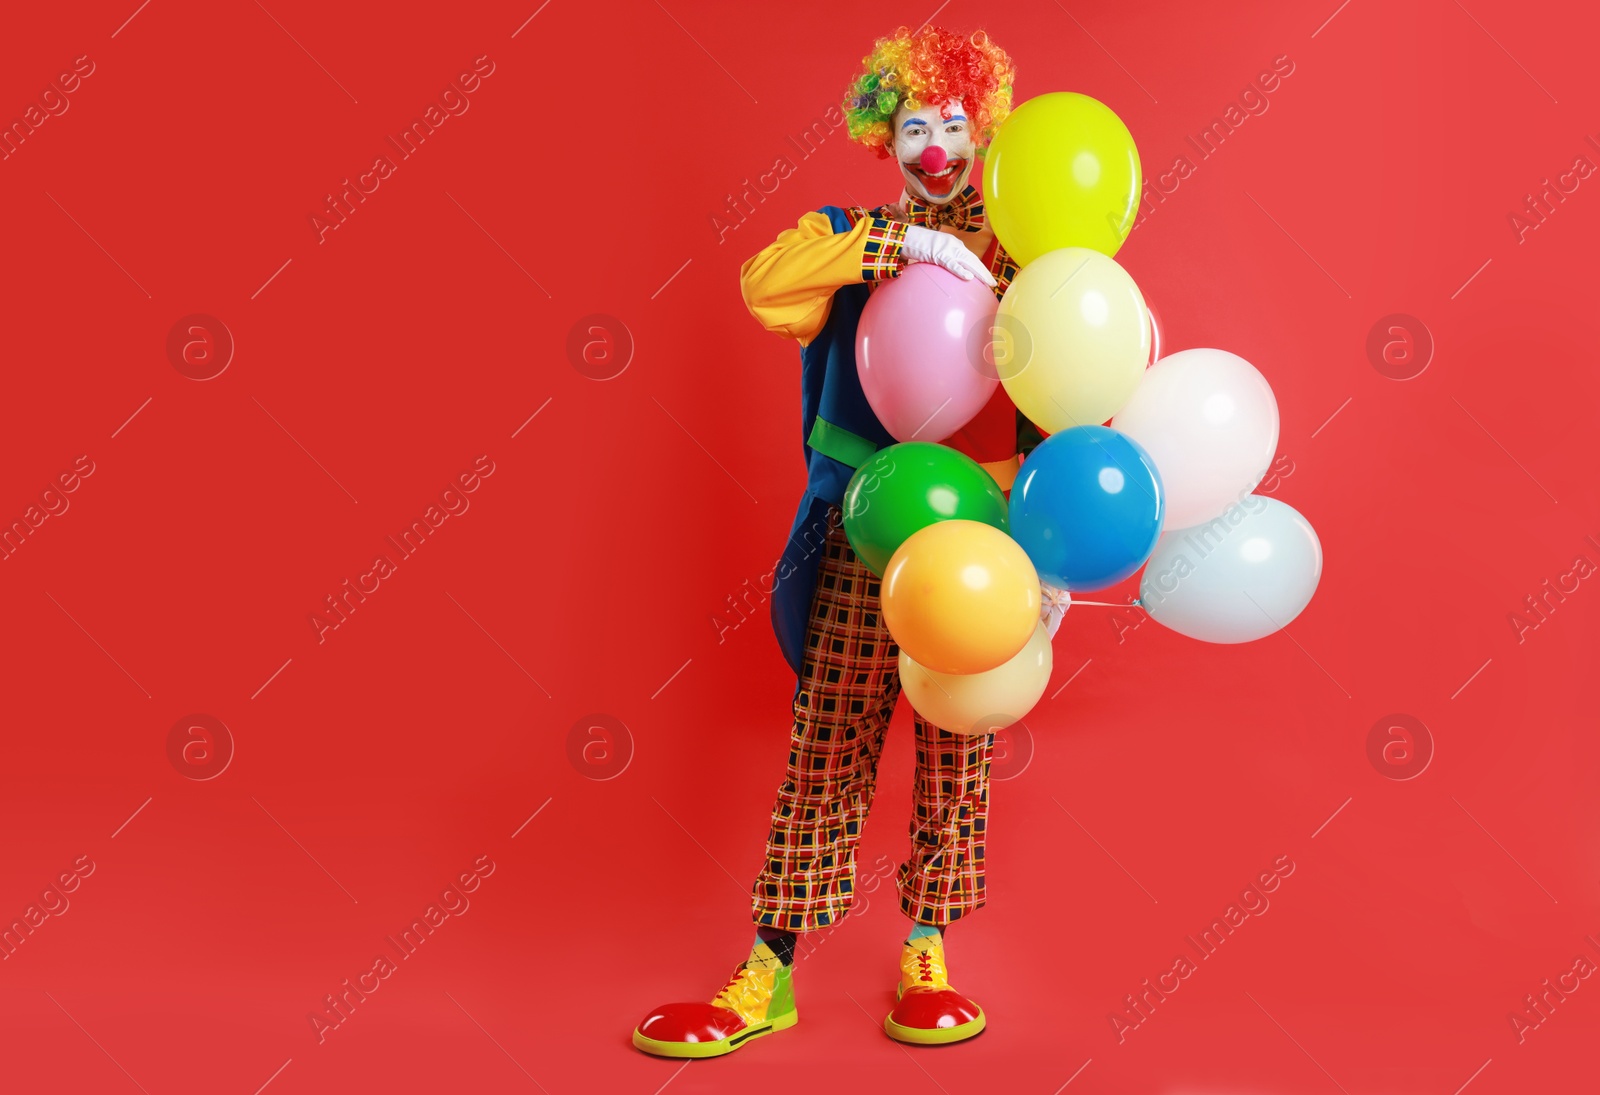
1139;495;1322;642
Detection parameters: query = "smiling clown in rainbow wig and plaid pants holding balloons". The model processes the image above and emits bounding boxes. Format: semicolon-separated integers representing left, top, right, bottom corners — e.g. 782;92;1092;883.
634;27;1061;1057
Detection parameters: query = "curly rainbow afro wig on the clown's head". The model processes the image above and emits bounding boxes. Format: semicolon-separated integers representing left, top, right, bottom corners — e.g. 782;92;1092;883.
843;26;1016;157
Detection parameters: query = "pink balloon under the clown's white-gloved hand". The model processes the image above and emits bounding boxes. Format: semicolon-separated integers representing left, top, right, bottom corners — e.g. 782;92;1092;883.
856;263;1000;442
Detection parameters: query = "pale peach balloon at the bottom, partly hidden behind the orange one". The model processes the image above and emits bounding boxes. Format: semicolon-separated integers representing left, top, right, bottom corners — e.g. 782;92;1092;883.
899;623;1053;735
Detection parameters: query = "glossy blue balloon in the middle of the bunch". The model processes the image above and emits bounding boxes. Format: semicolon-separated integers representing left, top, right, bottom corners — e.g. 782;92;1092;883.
1011;426;1166;592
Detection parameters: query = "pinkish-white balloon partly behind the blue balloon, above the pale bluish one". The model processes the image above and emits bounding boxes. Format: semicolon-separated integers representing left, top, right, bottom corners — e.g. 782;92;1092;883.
1110;349;1278;528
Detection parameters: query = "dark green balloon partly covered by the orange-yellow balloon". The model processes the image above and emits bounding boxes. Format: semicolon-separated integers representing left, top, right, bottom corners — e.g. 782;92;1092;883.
843;442;1011;578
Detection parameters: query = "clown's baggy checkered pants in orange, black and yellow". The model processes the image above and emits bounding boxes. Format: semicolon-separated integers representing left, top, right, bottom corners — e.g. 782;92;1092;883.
752;509;994;932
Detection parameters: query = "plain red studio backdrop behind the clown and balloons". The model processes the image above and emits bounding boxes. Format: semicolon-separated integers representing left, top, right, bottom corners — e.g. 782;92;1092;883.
0;0;1600;1095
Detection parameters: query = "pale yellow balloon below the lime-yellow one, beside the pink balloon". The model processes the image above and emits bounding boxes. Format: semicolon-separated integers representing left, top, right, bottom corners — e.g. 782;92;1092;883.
994;247;1150;434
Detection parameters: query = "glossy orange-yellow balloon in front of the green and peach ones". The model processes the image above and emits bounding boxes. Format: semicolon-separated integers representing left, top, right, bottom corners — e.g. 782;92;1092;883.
880;520;1038;672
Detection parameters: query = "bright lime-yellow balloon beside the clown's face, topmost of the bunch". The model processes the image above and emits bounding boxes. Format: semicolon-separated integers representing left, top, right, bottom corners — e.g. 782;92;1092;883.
984;91;1144;266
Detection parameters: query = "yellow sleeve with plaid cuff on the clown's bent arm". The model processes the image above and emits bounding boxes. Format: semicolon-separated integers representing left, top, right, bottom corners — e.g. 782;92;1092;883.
739;213;906;346
